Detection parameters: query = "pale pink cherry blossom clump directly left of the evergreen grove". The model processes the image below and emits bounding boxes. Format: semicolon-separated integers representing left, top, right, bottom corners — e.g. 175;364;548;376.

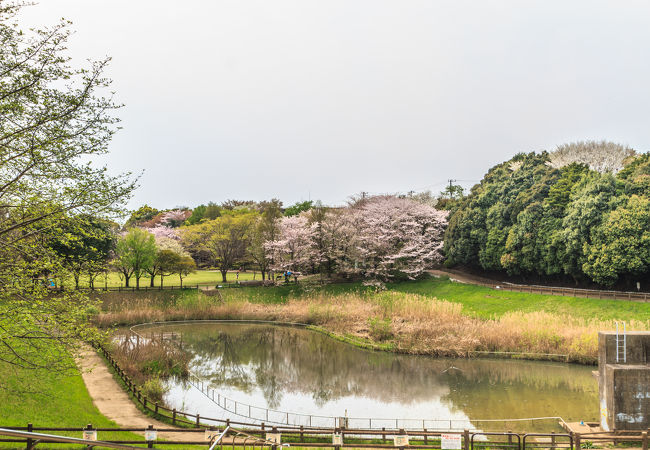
265;196;447;280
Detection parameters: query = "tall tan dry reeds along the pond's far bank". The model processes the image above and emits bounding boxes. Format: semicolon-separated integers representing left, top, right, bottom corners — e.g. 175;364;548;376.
96;291;650;363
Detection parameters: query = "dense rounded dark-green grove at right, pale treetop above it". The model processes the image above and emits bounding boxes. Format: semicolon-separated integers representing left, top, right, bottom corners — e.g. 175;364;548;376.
445;142;650;288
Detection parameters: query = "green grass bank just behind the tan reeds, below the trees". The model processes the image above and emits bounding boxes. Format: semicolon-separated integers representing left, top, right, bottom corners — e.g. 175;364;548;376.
224;278;650;321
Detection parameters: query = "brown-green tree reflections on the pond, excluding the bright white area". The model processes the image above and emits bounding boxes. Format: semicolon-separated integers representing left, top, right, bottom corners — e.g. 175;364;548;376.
159;324;597;418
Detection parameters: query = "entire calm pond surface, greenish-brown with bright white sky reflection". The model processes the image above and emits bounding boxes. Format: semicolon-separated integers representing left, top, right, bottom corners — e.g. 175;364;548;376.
138;322;598;431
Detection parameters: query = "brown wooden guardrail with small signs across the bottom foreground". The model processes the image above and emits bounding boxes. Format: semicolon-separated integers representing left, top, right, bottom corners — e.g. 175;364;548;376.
5;424;648;450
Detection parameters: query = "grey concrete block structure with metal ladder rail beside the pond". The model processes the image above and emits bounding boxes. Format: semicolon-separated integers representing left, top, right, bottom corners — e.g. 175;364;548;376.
598;329;650;431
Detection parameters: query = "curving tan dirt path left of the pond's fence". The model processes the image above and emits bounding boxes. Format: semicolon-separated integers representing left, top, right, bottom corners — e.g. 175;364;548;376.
77;347;203;441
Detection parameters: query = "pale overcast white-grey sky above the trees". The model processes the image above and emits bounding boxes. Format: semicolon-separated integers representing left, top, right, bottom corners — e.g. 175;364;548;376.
20;0;650;208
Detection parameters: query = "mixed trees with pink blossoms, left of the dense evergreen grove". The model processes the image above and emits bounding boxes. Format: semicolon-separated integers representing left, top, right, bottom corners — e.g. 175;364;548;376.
50;195;447;288
